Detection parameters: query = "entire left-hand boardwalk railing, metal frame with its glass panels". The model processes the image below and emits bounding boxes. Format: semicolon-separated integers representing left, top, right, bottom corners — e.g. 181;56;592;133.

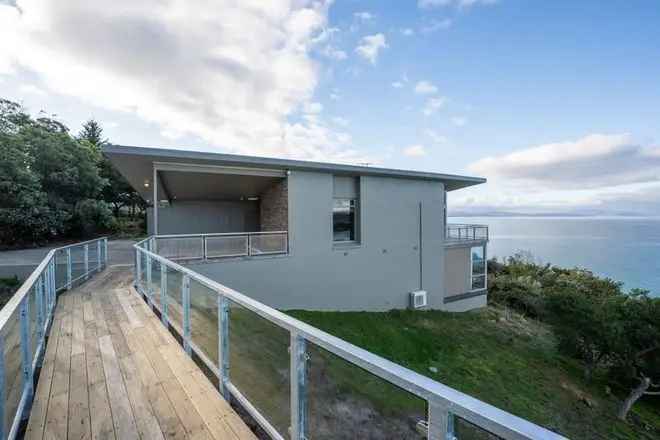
0;237;108;439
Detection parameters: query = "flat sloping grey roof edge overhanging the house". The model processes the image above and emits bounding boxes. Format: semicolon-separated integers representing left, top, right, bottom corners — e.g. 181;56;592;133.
103;144;486;191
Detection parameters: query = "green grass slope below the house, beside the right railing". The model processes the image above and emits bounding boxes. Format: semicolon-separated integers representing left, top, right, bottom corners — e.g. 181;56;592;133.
288;308;660;439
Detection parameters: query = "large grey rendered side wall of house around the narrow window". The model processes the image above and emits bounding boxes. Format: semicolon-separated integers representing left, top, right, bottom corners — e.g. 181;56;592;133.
189;171;445;311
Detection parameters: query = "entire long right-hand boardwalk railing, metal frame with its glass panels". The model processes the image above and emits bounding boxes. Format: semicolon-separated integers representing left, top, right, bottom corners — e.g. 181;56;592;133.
135;237;564;440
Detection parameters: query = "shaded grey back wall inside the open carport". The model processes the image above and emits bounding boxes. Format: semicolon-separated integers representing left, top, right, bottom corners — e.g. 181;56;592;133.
147;200;259;235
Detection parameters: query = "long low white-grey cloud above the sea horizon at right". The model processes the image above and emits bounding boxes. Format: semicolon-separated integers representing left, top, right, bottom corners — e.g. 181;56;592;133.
469;134;660;189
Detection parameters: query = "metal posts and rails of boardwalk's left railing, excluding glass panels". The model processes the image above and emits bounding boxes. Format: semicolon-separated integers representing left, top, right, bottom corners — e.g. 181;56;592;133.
0;237;108;439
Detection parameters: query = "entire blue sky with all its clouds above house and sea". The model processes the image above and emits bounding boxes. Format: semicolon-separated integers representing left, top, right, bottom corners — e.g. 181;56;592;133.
0;0;660;216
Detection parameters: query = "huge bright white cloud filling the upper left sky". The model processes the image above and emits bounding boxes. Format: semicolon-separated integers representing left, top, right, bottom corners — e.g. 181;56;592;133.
0;0;372;160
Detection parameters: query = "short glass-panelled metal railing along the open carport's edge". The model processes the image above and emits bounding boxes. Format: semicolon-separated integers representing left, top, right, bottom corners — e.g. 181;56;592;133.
151;231;289;261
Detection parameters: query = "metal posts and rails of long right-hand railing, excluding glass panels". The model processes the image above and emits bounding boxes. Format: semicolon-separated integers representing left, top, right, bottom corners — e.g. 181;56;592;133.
134;237;564;440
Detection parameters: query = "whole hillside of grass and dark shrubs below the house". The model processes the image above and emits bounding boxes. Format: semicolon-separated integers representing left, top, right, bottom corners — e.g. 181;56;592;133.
289;257;660;439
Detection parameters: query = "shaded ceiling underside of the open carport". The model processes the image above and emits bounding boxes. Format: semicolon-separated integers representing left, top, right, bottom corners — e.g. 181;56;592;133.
158;171;282;200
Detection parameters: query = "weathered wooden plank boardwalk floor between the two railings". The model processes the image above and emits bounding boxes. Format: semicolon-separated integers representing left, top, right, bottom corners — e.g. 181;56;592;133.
25;268;256;440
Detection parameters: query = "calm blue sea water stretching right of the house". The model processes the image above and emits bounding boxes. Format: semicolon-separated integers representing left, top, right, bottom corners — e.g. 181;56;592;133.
448;217;660;296
